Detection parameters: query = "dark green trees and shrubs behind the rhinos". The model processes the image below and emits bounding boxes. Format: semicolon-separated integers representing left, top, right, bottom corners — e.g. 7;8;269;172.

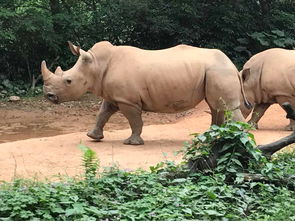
0;0;295;98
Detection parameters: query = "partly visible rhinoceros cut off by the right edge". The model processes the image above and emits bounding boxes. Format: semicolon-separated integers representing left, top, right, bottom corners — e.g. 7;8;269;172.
240;48;295;130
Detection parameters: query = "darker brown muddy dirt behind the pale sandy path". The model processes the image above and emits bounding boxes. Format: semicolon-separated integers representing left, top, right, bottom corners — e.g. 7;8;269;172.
0;94;184;143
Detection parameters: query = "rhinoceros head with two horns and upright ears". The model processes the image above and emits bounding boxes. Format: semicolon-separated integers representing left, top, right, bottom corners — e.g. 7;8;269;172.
41;42;94;103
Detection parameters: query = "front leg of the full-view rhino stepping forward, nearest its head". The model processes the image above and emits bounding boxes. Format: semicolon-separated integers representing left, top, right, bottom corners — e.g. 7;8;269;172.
87;100;119;141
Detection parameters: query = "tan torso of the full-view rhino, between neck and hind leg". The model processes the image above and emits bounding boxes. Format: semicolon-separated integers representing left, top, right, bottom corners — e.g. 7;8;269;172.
104;45;238;113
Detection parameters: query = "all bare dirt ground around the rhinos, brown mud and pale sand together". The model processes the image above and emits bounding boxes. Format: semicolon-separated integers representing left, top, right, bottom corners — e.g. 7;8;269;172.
0;95;293;180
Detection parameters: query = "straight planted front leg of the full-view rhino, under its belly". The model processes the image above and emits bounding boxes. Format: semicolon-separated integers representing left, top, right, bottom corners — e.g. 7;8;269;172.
118;104;144;145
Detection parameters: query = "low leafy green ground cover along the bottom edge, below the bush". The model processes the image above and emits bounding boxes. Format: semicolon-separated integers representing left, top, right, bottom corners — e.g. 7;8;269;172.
0;152;295;220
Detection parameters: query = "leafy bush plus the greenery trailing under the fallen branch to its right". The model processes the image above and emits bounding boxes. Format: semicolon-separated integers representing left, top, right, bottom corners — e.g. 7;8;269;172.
183;121;295;189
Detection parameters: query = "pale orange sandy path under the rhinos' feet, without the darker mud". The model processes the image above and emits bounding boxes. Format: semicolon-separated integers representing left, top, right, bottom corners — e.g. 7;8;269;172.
0;103;293;181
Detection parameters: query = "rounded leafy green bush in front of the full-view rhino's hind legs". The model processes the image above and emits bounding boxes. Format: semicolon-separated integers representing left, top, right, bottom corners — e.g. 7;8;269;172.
184;121;266;175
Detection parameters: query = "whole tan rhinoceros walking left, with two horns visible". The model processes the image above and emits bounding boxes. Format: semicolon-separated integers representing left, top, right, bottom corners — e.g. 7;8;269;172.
41;41;251;145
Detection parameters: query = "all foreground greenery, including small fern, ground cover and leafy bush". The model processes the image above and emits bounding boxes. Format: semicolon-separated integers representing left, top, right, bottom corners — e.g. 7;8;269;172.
0;123;295;221
